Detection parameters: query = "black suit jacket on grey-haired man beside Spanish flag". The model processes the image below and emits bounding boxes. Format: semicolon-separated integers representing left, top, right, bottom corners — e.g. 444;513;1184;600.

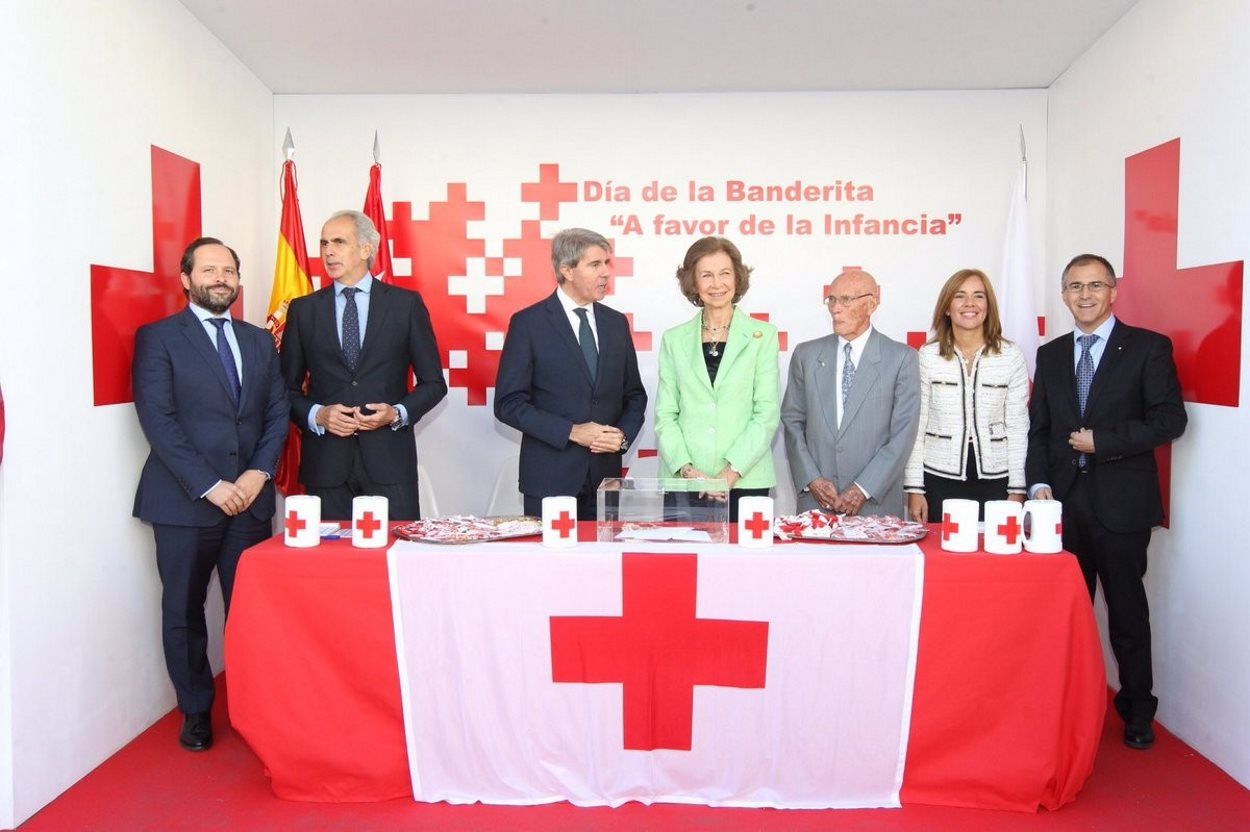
281;280;448;487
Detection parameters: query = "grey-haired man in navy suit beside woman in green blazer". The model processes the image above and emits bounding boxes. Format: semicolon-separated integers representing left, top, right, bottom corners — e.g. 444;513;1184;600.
495;223;646;520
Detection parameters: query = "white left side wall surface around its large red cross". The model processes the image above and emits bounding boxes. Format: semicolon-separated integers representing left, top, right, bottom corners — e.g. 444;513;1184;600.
0;0;276;827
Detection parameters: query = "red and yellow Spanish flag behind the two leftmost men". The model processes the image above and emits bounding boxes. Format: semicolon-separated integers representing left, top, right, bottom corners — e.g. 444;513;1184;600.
265;153;313;495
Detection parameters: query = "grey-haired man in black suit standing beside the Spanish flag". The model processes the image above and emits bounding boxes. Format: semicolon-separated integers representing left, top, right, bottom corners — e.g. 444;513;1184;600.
281;211;448;520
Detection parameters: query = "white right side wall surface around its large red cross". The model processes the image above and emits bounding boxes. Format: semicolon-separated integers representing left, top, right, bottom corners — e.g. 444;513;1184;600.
1046;0;1250;785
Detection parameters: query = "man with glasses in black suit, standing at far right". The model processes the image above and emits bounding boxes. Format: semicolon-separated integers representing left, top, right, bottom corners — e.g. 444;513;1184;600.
1025;254;1188;750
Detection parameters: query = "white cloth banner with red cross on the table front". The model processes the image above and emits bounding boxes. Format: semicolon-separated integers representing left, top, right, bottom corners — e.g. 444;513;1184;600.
389;542;924;808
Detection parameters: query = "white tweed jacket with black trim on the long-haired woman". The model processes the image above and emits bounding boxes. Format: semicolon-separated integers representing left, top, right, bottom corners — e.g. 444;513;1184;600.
903;341;1029;493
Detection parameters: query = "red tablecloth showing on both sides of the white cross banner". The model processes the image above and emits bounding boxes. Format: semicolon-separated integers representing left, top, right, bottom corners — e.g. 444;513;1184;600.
225;528;1106;811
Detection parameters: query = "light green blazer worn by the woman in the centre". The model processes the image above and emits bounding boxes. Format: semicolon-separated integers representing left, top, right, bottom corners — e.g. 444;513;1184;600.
655;309;781;488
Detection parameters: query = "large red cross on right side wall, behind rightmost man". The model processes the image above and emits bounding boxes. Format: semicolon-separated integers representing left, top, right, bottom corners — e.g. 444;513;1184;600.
1115;139;1244;526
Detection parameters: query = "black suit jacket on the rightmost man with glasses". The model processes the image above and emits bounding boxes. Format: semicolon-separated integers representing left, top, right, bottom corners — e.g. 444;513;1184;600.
1025;320;1186;532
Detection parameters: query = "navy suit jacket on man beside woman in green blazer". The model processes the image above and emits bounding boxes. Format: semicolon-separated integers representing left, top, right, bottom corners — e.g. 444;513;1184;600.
495;290;646;497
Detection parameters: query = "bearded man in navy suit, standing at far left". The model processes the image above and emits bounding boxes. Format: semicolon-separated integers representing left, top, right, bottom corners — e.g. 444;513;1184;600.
133;237;288;751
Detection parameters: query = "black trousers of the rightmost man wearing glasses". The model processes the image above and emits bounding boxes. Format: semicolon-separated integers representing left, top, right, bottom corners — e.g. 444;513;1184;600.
1064;473;1159;722
